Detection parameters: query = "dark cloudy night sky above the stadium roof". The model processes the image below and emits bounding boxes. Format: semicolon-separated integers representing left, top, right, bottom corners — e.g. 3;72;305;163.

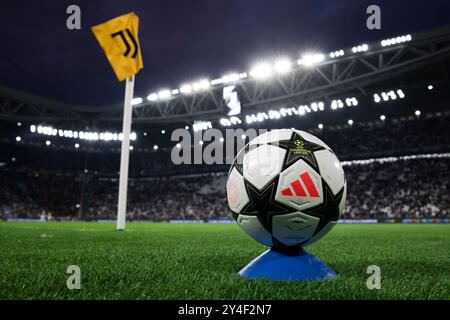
0;0;450;106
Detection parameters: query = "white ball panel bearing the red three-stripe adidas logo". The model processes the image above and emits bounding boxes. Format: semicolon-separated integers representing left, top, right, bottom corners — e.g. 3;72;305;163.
275;160;323;211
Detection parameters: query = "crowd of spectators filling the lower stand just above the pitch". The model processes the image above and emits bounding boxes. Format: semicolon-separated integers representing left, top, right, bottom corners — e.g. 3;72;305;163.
0;158;450;221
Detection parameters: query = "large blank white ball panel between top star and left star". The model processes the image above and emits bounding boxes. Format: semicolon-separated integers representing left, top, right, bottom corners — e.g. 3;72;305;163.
243;144;286;190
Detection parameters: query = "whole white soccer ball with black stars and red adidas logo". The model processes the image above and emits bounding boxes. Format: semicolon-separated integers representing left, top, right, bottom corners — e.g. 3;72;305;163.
226;129;347;251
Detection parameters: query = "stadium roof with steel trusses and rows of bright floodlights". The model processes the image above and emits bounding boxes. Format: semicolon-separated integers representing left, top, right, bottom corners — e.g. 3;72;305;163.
0;26;450;126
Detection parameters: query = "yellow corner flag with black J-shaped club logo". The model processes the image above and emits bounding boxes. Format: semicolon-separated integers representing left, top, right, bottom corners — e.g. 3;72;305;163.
92;12;143;81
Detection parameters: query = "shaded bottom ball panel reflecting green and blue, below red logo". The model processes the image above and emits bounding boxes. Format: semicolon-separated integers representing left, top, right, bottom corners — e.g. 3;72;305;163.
272;212;320;246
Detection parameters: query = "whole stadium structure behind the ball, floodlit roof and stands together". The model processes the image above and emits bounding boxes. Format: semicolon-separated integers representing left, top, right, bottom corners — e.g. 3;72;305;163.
0;26;450;221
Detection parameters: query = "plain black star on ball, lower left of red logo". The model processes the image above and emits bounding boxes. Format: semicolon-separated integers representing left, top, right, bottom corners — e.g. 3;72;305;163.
241;179;296;232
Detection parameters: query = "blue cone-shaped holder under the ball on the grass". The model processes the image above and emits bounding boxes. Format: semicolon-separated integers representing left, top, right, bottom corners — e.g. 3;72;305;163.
239;249;338;281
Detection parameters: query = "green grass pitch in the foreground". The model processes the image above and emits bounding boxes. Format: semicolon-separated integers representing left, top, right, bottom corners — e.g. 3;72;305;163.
0;222;450;300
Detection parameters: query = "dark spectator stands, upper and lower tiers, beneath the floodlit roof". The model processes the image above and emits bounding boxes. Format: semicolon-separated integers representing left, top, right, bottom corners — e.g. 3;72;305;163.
0;117;450;221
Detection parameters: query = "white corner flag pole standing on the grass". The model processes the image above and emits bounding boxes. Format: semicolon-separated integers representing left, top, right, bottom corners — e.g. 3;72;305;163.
117;76;134;230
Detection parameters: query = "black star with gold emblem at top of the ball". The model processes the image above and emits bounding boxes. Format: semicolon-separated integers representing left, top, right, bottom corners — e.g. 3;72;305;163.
274;132;325;174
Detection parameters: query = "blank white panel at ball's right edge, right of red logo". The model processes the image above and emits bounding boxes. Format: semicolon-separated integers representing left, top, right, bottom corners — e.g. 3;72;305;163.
314;150;344;195
